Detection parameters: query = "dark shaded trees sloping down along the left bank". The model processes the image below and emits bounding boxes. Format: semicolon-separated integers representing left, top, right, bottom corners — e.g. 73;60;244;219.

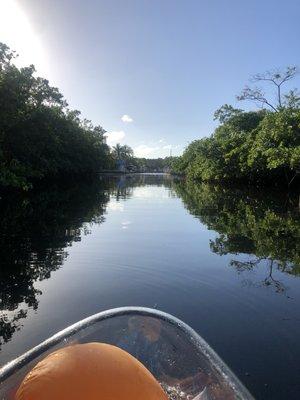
0;43;113;189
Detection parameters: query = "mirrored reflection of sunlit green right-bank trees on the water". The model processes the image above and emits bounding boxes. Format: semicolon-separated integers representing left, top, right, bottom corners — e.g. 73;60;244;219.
175;182;300;293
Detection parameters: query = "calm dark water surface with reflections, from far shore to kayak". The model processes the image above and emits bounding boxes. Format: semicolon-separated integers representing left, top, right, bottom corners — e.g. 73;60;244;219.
0;175;300;400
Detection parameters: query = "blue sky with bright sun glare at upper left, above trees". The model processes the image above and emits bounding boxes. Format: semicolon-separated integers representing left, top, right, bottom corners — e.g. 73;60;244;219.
0;0;300;158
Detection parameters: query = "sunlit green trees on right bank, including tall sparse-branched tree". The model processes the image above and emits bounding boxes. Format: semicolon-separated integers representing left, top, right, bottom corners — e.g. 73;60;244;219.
173;67;300;185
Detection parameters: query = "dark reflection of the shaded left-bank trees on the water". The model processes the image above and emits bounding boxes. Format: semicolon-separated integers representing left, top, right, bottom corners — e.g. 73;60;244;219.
0;182;109;347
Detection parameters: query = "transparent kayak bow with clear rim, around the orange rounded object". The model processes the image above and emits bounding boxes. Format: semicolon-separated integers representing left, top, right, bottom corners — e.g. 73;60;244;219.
0;307;253;400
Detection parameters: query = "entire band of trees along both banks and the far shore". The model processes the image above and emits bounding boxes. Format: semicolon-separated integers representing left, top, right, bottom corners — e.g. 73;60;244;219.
0;42;300;190
